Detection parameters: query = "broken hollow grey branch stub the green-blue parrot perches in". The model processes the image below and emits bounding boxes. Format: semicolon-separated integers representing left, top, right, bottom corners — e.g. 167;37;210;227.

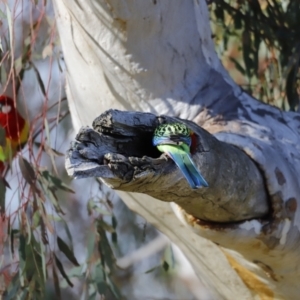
68;110;269;222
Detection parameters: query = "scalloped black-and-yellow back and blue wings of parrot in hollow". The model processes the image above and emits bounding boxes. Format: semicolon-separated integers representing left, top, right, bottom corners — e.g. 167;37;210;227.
153;123;194;147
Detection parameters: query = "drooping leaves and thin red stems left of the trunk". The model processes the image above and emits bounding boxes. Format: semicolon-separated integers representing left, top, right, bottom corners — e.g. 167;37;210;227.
0;1;121;300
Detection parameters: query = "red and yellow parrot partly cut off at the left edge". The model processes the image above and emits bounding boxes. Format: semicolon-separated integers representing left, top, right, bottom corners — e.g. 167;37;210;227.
0;95;29;177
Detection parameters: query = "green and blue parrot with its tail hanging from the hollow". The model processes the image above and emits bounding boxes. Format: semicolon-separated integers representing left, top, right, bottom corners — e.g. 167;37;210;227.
152;123;208;189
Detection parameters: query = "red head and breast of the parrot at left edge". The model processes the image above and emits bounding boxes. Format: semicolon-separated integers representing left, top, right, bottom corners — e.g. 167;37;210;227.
0;95;25;138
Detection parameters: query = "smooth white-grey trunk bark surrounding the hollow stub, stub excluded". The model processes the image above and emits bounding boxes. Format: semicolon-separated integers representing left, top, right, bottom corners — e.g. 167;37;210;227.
54;0;300;299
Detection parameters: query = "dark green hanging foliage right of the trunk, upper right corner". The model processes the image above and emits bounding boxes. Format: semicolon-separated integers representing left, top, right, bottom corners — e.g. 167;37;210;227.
209;0;300;110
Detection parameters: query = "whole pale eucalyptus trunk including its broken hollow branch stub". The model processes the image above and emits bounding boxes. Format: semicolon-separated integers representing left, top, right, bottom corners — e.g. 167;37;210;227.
54;0;300;299
